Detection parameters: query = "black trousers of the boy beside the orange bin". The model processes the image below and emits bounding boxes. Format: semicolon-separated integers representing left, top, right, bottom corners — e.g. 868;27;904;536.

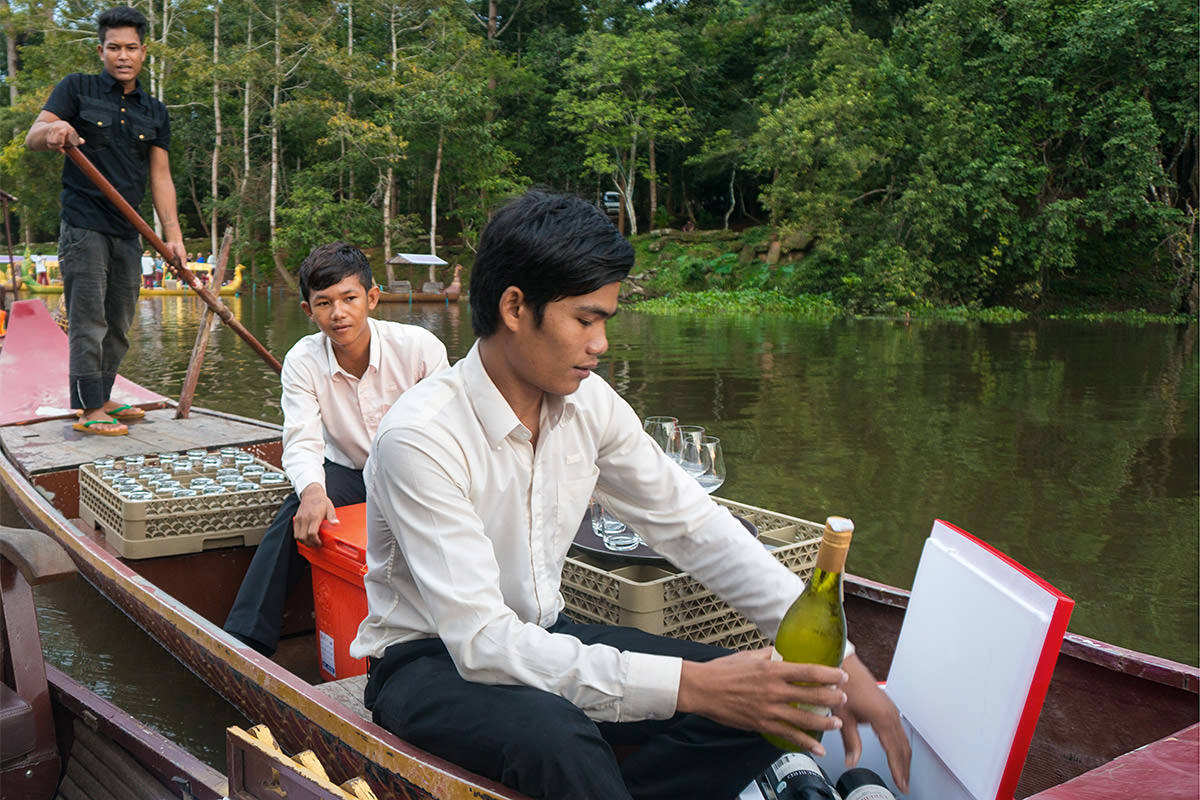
224;461;366;656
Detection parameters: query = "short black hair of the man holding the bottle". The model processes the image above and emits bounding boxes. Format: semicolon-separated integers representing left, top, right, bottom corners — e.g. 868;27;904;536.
470;190;634;338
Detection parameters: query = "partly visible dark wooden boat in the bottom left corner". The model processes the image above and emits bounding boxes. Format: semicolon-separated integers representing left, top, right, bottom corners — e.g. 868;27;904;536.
0;525;384;800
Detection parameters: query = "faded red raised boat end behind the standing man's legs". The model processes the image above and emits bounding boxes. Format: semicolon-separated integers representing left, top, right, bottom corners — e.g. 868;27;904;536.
0;300;167;424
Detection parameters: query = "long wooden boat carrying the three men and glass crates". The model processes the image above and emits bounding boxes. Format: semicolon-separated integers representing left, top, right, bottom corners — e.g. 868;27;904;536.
0;301;1200;800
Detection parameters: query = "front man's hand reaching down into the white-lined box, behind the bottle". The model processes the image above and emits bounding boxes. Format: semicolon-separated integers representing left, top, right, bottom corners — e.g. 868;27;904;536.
834;655;912;794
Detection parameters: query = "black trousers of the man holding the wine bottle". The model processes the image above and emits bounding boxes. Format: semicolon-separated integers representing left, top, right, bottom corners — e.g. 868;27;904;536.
364;616;780;800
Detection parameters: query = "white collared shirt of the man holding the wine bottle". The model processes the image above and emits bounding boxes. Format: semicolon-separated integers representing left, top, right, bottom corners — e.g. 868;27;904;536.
350;343;804;721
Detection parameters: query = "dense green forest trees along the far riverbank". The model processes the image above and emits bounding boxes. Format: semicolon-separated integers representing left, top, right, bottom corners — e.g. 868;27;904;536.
0;0;1200;312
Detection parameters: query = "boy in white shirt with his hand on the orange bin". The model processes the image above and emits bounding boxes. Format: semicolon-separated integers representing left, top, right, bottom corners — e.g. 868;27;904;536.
224;242;450;655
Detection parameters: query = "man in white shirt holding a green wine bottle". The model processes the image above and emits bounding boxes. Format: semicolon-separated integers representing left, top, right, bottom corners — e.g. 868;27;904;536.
350;192;910;800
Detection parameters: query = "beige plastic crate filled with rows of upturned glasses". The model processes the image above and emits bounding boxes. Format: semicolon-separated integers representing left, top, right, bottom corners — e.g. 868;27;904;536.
79;450;292;559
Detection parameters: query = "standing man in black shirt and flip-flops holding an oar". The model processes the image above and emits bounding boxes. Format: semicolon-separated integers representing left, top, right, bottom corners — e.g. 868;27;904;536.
25;6;186;435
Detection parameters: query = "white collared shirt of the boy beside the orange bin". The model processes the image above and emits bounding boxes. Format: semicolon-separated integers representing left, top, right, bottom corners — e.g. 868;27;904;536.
280;318;450;494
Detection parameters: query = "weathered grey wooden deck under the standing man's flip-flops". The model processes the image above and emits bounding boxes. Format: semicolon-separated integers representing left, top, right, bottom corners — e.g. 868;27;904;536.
0;408;280;476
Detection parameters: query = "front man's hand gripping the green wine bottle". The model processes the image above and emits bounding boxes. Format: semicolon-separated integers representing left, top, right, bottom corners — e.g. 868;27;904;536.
676;648;847;756
